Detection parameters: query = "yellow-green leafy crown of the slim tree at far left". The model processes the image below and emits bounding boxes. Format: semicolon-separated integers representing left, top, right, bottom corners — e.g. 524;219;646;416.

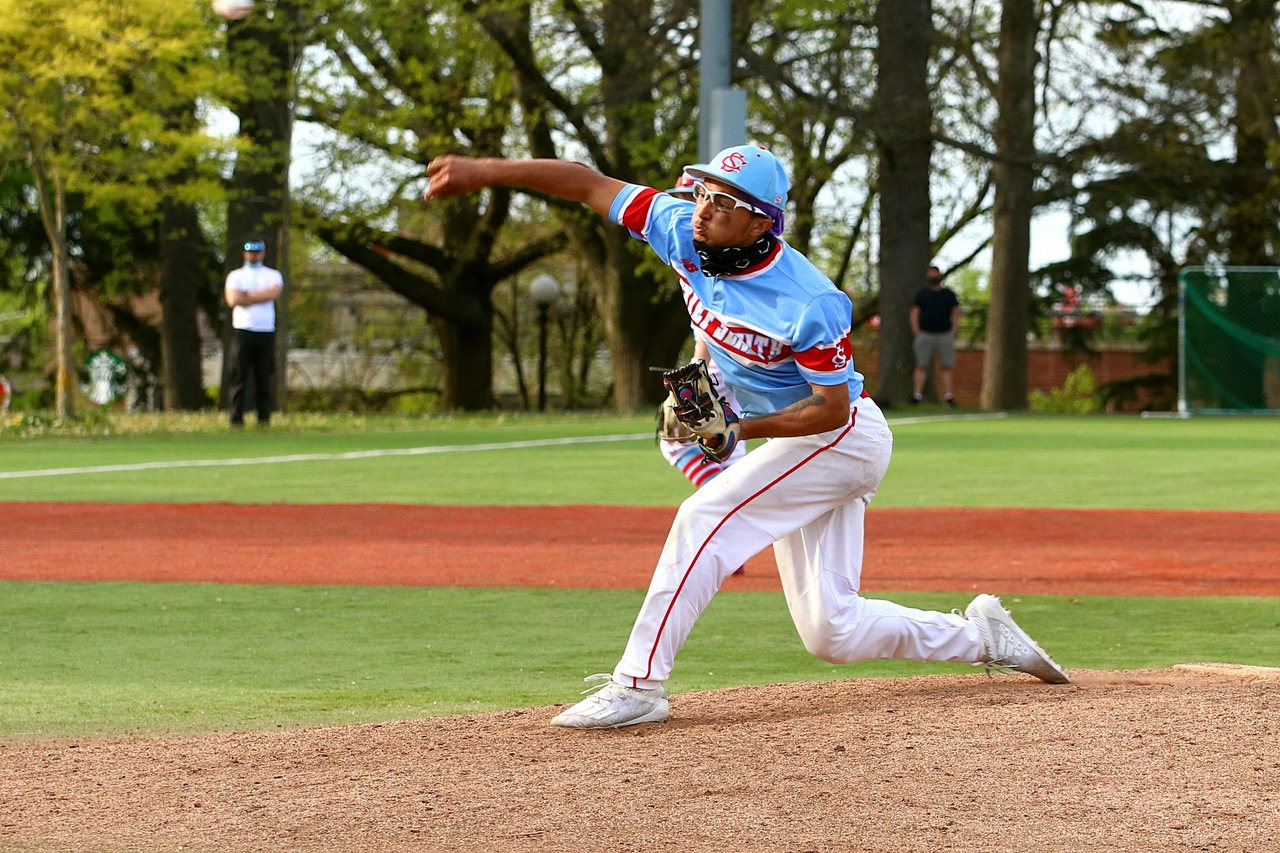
0;0;219;215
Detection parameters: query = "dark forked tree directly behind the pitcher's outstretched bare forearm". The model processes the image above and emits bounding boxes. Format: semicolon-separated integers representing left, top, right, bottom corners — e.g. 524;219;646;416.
300;3;566;410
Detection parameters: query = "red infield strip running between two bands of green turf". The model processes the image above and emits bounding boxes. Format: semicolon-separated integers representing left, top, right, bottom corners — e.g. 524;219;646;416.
0;503;1280;596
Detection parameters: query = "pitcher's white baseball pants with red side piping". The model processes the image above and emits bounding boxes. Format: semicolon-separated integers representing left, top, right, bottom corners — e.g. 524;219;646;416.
613;397;986;689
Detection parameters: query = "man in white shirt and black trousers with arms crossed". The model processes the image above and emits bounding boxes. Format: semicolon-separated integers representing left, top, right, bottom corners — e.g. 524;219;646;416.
223;237;284;429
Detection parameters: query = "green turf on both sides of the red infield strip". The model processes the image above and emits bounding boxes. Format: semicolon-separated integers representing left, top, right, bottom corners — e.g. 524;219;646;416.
0;416;1280;739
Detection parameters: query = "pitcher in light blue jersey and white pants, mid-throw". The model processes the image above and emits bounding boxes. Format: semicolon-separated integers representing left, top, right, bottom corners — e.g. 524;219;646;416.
424;145;1068;729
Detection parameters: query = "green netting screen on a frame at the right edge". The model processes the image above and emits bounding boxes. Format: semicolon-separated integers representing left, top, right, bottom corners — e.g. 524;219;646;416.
1178;266;1280;415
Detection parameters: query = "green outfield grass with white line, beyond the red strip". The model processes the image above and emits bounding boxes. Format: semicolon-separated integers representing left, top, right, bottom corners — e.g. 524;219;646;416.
0;415;1280;511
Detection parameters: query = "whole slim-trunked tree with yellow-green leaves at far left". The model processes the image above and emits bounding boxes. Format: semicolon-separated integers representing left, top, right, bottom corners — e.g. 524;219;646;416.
0;0;217;418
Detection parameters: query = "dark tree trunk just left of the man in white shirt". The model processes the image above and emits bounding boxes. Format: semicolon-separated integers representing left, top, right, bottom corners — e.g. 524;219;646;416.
160;199;209;411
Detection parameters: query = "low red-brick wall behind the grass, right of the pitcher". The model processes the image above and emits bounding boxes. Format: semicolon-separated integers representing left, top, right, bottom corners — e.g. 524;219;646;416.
854;341;1172;411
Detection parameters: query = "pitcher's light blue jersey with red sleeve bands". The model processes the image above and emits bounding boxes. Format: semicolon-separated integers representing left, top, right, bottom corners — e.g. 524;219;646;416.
609;184;863;415
